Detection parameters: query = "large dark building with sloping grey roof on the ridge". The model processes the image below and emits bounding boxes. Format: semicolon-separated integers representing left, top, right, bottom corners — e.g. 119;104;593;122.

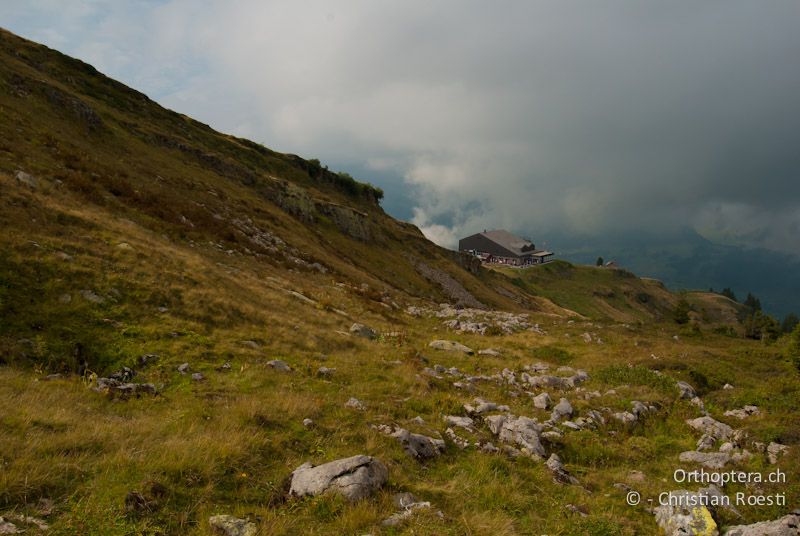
458;229;553;266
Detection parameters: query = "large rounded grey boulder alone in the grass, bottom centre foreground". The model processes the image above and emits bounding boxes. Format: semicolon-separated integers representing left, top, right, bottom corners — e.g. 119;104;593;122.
289;454;389;501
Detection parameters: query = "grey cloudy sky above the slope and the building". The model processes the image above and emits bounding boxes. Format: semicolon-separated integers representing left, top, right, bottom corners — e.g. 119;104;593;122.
0;0;800;254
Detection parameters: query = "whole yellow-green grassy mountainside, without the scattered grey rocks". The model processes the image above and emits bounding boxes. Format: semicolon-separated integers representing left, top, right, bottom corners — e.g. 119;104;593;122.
0;31;800;535
